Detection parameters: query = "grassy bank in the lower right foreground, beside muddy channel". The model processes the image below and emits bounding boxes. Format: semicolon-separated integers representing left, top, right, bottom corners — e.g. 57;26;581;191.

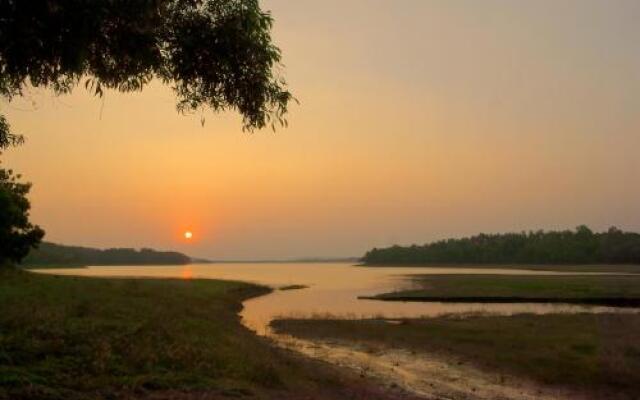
272;314;640;399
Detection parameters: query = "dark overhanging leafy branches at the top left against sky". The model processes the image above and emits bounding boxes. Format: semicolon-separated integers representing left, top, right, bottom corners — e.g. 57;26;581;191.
0;0;292;148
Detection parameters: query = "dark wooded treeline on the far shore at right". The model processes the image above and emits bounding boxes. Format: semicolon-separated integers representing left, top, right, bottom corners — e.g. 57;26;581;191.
362;225;640;265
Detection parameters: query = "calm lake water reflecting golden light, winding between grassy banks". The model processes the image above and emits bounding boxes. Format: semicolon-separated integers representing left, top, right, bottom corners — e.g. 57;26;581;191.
35;263;632;335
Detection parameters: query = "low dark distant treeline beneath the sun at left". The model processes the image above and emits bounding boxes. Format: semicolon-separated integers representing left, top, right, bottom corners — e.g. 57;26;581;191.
22;242;191;266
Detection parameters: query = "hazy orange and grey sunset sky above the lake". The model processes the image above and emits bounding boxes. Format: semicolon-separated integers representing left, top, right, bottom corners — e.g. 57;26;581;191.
0;0;640;260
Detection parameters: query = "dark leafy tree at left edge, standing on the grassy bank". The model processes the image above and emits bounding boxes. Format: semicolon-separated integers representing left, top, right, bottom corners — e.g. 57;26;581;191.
0;168;44;266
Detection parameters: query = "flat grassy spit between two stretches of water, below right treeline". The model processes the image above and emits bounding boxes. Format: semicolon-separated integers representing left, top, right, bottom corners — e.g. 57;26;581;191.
362;275;640;307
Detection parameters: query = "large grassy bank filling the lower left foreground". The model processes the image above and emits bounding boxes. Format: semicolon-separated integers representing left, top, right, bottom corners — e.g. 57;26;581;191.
0;271;416;400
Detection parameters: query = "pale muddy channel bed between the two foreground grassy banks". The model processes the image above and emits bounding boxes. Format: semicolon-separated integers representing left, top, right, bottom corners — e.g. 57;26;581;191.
262;326;580;400
